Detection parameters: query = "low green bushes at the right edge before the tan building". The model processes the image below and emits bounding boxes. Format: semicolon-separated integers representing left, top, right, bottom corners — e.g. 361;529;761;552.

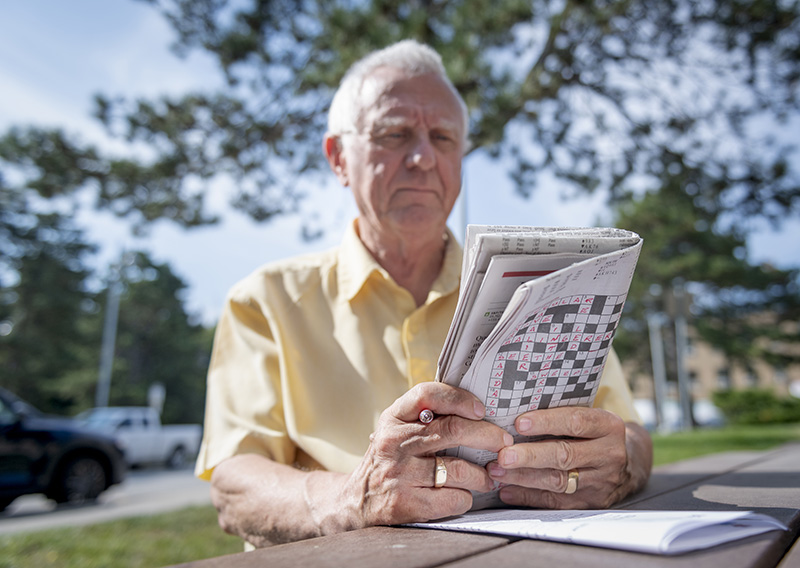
713;389;800;424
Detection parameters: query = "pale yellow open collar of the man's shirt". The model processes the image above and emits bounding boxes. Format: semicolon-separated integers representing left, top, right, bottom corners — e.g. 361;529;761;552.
338;220;462;302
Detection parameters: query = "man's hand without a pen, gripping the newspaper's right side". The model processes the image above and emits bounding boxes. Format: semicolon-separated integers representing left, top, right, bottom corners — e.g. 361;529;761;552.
487;407;653;509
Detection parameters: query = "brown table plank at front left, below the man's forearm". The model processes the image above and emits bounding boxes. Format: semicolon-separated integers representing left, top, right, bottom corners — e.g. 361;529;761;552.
172;527;510;568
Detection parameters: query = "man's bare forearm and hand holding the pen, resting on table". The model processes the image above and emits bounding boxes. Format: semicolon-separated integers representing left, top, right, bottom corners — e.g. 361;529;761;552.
211;383;514;547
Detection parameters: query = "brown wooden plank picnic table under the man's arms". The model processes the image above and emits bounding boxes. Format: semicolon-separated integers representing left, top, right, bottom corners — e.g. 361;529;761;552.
175;442;800;568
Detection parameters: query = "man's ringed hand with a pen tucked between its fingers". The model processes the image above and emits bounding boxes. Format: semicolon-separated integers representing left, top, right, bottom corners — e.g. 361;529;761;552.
330;383;513;528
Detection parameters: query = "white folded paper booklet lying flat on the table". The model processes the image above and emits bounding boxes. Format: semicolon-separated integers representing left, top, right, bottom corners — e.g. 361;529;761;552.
410;509;787;554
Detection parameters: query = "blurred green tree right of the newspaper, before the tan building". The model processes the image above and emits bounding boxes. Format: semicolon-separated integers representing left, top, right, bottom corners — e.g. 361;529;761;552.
614;169;800;376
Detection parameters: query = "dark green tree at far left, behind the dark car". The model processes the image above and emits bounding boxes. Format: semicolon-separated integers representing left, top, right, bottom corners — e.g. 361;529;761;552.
0;180;99;414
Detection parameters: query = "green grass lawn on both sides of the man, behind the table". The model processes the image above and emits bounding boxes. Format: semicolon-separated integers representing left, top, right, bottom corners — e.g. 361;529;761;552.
0;424;800;568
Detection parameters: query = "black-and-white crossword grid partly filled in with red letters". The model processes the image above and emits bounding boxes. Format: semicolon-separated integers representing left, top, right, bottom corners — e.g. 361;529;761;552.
486;294;625;417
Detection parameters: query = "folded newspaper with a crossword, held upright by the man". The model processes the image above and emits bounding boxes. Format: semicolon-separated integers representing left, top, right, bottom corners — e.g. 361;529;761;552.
436;225;642;508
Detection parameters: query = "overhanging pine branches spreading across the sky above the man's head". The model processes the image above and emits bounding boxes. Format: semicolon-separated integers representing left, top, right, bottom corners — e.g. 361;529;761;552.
0;0;800;232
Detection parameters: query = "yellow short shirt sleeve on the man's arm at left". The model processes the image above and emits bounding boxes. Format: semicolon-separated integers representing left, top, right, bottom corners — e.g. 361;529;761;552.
195;292;296;480
